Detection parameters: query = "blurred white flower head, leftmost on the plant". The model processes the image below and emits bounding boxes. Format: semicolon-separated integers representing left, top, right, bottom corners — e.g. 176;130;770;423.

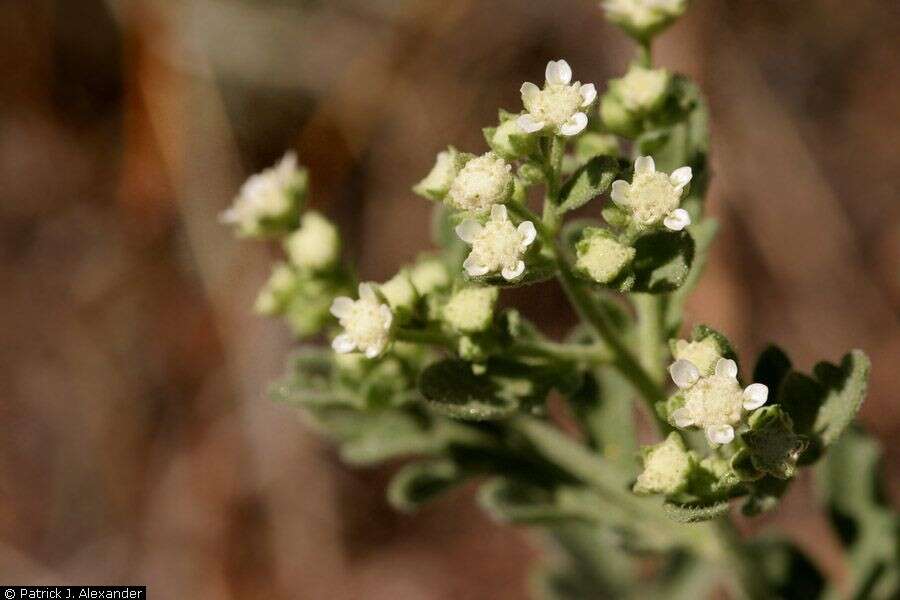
219;152;306;235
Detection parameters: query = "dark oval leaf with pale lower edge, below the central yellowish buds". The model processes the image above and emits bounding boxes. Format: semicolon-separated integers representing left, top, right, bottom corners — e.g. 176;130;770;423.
419;359;519;421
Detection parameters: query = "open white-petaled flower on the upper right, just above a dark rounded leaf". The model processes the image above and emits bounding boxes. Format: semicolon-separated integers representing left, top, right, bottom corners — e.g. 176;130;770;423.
610;156;691;231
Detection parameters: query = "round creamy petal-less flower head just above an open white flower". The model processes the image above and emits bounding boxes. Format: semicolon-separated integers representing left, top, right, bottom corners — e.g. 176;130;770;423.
447;152;513;212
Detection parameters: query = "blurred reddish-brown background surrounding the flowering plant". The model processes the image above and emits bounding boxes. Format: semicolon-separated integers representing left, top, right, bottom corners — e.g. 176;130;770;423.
0;0;900;599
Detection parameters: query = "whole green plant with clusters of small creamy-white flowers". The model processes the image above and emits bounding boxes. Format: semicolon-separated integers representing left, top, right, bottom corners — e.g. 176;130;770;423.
223;0;900;598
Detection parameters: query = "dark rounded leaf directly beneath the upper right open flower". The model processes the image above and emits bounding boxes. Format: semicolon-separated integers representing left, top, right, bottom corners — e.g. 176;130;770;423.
614;231;694;294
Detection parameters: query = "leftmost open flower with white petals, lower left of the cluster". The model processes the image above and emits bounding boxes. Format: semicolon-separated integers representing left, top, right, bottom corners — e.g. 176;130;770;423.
331;283;394;358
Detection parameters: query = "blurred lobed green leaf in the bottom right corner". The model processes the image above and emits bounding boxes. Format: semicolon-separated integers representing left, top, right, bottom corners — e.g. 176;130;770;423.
816;428;900;599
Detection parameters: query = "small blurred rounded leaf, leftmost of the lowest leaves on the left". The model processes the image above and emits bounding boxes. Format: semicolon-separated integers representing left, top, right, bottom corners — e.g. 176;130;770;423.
387;460;466;512
